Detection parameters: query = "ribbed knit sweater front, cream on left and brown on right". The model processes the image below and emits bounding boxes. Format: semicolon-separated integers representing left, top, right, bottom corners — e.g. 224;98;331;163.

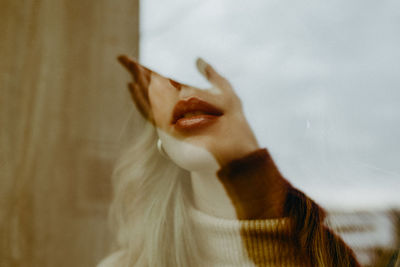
190;204;302;267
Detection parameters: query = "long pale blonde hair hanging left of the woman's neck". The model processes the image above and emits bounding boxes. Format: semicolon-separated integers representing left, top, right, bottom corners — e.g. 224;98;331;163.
110;123;199;267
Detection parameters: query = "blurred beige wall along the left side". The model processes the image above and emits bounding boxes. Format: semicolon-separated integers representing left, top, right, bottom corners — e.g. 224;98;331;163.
0;0;138;267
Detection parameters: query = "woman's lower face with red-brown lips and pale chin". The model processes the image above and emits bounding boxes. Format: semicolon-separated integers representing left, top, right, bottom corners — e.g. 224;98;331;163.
149;71;232;172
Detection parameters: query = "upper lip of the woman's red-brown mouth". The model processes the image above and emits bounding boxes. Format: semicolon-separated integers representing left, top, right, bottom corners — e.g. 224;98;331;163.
172;97;223;124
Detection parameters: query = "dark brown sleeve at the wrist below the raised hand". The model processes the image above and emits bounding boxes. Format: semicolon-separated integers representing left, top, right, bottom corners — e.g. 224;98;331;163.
217;149;290;220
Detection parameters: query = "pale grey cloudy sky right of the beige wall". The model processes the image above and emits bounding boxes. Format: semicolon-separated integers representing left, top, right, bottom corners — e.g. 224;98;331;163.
140;0;400;209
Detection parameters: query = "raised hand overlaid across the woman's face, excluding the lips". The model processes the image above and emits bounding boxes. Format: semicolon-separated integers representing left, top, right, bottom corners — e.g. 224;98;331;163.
118;56;259;166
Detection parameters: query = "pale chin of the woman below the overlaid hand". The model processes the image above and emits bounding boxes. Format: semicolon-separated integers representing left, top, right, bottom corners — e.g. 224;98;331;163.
158;130;219;172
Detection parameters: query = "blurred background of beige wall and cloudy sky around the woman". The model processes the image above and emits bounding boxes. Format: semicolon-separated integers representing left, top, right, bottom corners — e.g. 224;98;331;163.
0;0;400;267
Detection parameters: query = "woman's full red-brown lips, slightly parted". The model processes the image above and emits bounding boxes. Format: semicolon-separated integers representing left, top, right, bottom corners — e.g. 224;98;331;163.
172;97;223;132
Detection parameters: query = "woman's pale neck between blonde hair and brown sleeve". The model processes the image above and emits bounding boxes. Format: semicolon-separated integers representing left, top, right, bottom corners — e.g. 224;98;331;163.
190;170;237;219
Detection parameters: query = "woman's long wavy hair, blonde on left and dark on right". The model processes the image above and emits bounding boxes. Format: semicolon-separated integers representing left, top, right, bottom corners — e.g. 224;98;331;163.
110;120;359;267
